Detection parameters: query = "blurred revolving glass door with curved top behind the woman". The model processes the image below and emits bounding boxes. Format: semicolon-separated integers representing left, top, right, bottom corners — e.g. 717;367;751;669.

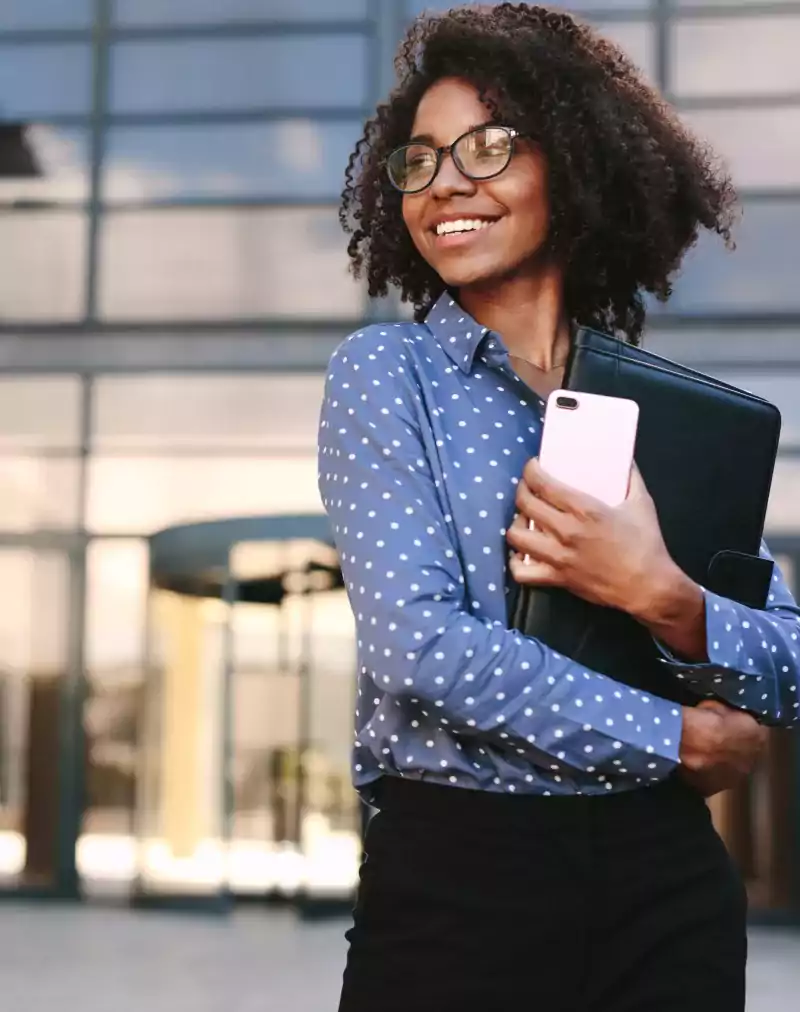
136;516;360;913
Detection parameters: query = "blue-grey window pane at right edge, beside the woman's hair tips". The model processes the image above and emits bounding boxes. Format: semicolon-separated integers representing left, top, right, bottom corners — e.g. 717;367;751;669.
669;200;800;313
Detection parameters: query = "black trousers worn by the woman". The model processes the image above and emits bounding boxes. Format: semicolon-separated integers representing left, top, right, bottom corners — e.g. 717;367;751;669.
339;778;746;1012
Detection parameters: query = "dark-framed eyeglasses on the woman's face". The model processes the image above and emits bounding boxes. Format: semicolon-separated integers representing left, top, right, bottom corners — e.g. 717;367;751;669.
386;127;520;193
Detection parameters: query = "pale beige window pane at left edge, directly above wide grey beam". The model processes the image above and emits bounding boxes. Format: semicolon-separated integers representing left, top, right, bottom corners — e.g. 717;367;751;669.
0;210;86;321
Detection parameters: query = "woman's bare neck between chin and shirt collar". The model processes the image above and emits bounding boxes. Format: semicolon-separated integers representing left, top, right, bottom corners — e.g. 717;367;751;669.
458;266;569;369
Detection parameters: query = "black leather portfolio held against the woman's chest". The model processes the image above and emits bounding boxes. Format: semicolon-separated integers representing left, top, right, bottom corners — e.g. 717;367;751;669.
512;329;781;703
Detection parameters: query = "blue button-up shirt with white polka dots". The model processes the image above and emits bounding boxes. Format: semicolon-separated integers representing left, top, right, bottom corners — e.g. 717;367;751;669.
319;296;800;798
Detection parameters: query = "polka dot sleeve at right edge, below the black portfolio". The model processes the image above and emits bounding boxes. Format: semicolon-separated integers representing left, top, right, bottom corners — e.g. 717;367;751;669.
665;543;800;727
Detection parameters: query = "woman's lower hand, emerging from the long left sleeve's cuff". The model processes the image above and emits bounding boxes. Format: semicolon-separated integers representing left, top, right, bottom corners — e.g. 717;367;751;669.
679;699;769;797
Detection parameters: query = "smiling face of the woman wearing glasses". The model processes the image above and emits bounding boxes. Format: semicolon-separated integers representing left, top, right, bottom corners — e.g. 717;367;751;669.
403;78;549;288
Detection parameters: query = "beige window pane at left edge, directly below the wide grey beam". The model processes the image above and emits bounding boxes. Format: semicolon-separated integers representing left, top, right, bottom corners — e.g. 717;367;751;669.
0;375;81;453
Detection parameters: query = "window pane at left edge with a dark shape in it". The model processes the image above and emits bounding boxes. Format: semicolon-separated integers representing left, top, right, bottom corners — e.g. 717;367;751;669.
0;123;89;203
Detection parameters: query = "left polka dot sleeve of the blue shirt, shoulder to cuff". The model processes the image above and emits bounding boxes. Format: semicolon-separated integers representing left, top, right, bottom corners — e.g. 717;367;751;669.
319;330;682;779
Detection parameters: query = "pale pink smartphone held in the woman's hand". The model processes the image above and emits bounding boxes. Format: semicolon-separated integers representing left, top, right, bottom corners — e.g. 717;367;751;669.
539;390;639;506
